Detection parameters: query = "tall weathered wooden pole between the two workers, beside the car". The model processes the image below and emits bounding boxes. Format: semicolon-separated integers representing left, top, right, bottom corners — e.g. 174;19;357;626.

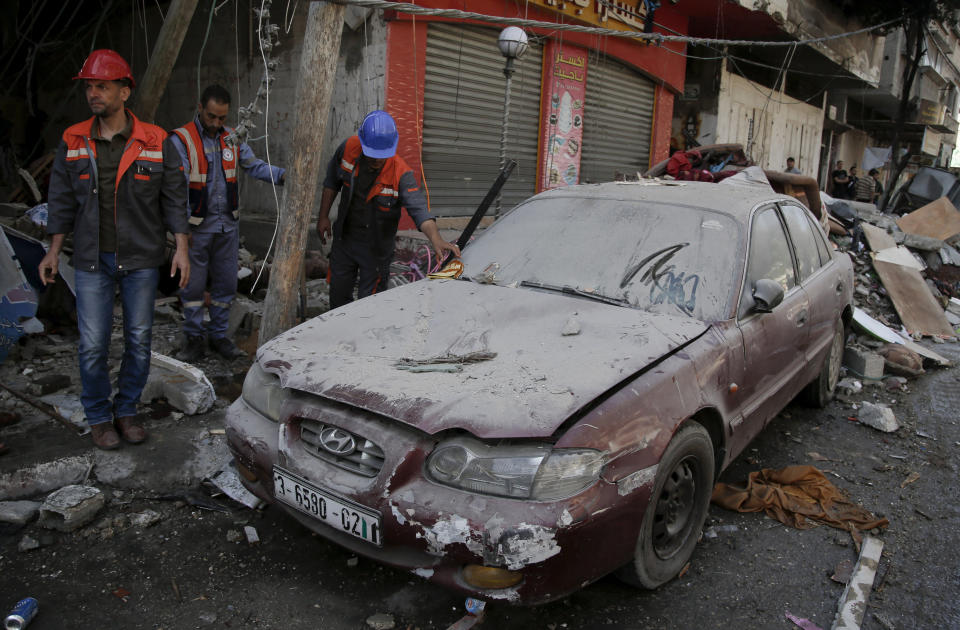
259;2;345;345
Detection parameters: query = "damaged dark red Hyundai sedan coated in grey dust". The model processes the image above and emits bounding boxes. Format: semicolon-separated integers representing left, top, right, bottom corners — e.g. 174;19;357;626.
227;174;853;604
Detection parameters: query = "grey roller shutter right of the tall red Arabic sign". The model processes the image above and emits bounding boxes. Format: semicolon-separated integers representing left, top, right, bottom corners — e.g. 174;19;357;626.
580;56;655;184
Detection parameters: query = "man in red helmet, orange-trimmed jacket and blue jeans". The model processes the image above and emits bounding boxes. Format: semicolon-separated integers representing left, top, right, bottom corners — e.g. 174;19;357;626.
39;50;190;449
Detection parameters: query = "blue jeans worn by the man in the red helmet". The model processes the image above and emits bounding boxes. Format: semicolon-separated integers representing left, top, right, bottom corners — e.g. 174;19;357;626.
76;252;160;426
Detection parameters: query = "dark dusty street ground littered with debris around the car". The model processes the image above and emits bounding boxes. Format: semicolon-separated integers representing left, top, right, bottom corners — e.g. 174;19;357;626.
0;331;960;630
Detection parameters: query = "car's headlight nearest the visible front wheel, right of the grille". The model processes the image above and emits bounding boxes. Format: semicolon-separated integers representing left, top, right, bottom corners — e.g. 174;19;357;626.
427;438;604;501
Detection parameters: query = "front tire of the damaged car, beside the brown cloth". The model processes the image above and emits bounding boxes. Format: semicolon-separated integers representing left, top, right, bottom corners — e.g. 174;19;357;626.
618;422;714;589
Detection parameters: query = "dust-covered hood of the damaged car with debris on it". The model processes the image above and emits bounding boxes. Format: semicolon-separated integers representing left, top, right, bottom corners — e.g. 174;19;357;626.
257;280;708;438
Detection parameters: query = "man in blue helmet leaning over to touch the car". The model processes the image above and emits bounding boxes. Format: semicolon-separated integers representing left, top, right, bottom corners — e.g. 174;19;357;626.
317;110;460;309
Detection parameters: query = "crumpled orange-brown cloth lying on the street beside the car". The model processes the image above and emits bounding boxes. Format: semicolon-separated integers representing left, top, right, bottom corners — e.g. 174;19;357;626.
711;466;890;533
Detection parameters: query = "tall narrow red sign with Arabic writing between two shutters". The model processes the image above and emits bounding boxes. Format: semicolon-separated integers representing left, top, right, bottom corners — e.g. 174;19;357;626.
537;40;587;191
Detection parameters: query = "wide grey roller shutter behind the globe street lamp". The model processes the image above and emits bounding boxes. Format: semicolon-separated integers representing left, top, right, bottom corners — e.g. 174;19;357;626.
423;23;542;216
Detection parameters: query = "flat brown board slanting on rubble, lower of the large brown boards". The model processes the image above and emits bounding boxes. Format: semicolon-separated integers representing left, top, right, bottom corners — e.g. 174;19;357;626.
873;260;954;337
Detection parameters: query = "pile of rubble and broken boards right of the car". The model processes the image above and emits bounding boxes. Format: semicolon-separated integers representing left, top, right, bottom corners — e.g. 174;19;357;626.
824;197;960;432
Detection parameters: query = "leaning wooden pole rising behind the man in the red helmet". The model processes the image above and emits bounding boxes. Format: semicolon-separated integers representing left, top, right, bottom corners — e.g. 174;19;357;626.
134;0;201;123
